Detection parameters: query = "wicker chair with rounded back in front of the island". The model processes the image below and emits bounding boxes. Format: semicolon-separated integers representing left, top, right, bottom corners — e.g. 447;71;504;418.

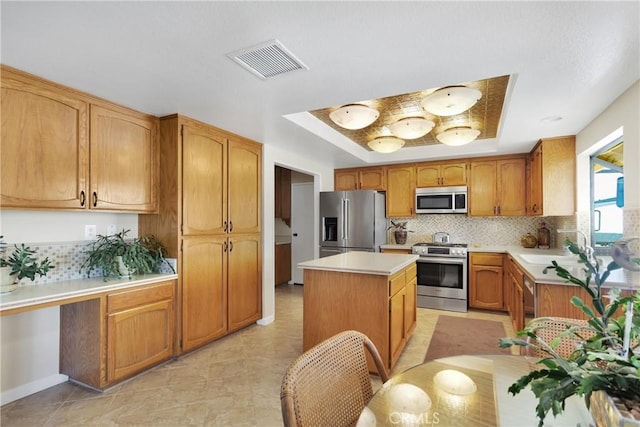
280;331;389;427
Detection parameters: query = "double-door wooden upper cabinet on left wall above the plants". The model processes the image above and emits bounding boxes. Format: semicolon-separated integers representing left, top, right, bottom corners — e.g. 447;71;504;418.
1;66;159;213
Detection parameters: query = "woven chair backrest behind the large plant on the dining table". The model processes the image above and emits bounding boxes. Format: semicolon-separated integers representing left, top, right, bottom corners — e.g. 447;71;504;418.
529;317;593;358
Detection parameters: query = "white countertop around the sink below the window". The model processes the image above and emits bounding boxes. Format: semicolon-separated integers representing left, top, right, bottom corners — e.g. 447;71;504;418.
468;245;640;289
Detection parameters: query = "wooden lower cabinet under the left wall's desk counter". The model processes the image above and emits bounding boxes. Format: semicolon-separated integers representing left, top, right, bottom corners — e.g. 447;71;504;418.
60;280;175;389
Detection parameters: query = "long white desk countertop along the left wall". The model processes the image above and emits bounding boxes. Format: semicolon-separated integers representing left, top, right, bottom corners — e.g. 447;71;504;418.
0;274;178;312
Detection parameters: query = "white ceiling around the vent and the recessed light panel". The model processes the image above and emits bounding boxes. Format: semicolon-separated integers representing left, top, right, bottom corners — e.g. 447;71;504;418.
0;1;640;167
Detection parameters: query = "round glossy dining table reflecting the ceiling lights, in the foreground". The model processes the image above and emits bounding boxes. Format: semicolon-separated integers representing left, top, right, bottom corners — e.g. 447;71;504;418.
358;355;595;427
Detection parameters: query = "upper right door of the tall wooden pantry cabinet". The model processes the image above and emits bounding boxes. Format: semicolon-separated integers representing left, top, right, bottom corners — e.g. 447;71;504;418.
228;138;262;234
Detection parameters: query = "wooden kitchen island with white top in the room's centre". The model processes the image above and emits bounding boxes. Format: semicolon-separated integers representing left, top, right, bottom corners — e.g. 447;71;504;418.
298;252;418;372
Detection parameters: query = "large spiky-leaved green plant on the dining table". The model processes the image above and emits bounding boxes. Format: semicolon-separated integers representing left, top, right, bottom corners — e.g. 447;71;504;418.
500;240;640;426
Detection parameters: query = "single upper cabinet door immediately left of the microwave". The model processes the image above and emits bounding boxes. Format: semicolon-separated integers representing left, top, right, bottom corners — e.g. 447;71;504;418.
386;167;416;218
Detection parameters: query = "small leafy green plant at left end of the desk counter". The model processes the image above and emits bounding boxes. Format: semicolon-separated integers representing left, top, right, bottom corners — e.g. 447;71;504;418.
0;236;54;292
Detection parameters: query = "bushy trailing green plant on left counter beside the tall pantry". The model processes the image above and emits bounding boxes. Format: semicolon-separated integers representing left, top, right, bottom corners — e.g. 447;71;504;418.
80;230;173;281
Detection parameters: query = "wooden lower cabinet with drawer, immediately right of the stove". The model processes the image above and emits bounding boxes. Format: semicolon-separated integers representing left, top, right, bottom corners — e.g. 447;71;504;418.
469;252;504;310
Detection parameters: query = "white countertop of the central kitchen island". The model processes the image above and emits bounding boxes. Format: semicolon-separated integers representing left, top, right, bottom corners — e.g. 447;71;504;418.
298;252;418;276
